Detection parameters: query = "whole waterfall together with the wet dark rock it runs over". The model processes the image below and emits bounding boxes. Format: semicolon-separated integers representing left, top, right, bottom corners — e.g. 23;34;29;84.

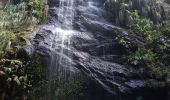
29;0;145;100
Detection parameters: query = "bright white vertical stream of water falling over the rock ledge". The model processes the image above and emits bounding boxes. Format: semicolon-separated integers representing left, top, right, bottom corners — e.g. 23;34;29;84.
52;0;74;76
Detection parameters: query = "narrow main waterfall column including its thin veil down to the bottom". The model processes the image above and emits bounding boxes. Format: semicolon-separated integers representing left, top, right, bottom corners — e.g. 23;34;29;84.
46;0;82;100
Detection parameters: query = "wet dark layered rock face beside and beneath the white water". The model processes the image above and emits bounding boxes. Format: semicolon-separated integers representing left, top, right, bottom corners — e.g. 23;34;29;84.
26;0;169;100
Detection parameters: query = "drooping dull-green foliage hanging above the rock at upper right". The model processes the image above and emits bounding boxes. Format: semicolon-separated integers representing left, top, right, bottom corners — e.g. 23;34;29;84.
105;0;164;26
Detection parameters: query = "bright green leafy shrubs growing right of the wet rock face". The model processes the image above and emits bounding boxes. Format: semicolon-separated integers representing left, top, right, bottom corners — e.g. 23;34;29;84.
128;11;162;65
